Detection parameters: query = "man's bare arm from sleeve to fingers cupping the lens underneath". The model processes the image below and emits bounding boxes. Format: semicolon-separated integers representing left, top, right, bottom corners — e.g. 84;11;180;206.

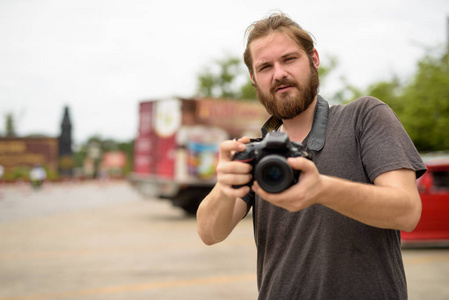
253;158;422;231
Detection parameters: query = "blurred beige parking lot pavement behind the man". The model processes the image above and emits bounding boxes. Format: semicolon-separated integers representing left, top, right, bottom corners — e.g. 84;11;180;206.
0;182;449;300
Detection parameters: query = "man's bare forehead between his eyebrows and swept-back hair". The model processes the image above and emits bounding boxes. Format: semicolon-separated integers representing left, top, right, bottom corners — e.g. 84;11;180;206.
250;32;304;64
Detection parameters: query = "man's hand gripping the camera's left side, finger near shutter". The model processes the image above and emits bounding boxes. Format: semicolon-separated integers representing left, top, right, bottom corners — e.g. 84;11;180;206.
217;137;252;199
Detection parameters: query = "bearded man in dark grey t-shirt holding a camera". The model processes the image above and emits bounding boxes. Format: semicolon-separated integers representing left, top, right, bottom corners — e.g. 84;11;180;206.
197;14;425;299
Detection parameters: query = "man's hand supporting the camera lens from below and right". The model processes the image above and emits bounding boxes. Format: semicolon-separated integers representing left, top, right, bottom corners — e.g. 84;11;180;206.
252;157;322;212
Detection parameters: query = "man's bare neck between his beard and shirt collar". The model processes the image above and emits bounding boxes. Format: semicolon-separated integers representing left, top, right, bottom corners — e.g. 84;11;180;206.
282;96;317;142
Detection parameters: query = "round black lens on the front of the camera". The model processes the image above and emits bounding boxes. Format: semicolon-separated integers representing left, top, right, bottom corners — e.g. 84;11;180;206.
255;155;293;193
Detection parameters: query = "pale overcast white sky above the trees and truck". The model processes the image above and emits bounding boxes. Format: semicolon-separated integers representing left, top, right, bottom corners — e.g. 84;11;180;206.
0;0;449;143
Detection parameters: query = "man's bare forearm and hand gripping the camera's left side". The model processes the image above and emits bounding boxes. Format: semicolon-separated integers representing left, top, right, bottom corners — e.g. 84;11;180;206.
197;138;251;245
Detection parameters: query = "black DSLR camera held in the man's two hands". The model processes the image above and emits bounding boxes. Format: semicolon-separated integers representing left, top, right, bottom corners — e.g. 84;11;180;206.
233;131;312;193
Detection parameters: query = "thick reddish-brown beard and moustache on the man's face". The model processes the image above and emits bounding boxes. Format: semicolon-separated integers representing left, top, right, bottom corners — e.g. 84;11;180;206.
254;65;320;120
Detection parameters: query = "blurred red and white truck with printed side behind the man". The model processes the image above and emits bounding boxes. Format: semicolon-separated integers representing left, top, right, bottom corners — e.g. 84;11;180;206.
130;98;269;214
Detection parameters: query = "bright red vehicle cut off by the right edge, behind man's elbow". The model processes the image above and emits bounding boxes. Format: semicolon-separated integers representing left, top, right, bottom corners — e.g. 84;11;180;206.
401;155;449;246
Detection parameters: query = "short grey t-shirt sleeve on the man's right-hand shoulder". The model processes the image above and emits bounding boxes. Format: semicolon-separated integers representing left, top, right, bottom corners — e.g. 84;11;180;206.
358;98;426;182
